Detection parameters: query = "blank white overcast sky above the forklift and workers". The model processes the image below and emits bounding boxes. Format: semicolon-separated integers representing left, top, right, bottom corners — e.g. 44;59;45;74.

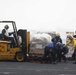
0;0;76;32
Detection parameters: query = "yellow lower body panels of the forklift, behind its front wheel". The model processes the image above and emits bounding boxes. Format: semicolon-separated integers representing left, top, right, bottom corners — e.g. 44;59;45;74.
0;41;20;60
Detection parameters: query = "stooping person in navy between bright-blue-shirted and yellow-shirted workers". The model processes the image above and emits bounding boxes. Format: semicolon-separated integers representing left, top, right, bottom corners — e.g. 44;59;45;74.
55;43;69;62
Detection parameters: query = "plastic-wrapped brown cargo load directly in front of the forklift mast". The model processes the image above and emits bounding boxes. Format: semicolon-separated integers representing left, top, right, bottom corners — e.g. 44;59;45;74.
29;33;52;57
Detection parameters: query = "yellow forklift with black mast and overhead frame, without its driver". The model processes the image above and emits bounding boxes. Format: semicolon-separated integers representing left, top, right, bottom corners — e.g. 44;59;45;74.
0;21;28;62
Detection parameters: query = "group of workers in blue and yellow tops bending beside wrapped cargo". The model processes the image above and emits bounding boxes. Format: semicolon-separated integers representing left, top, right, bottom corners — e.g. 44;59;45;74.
41;34;76;64
